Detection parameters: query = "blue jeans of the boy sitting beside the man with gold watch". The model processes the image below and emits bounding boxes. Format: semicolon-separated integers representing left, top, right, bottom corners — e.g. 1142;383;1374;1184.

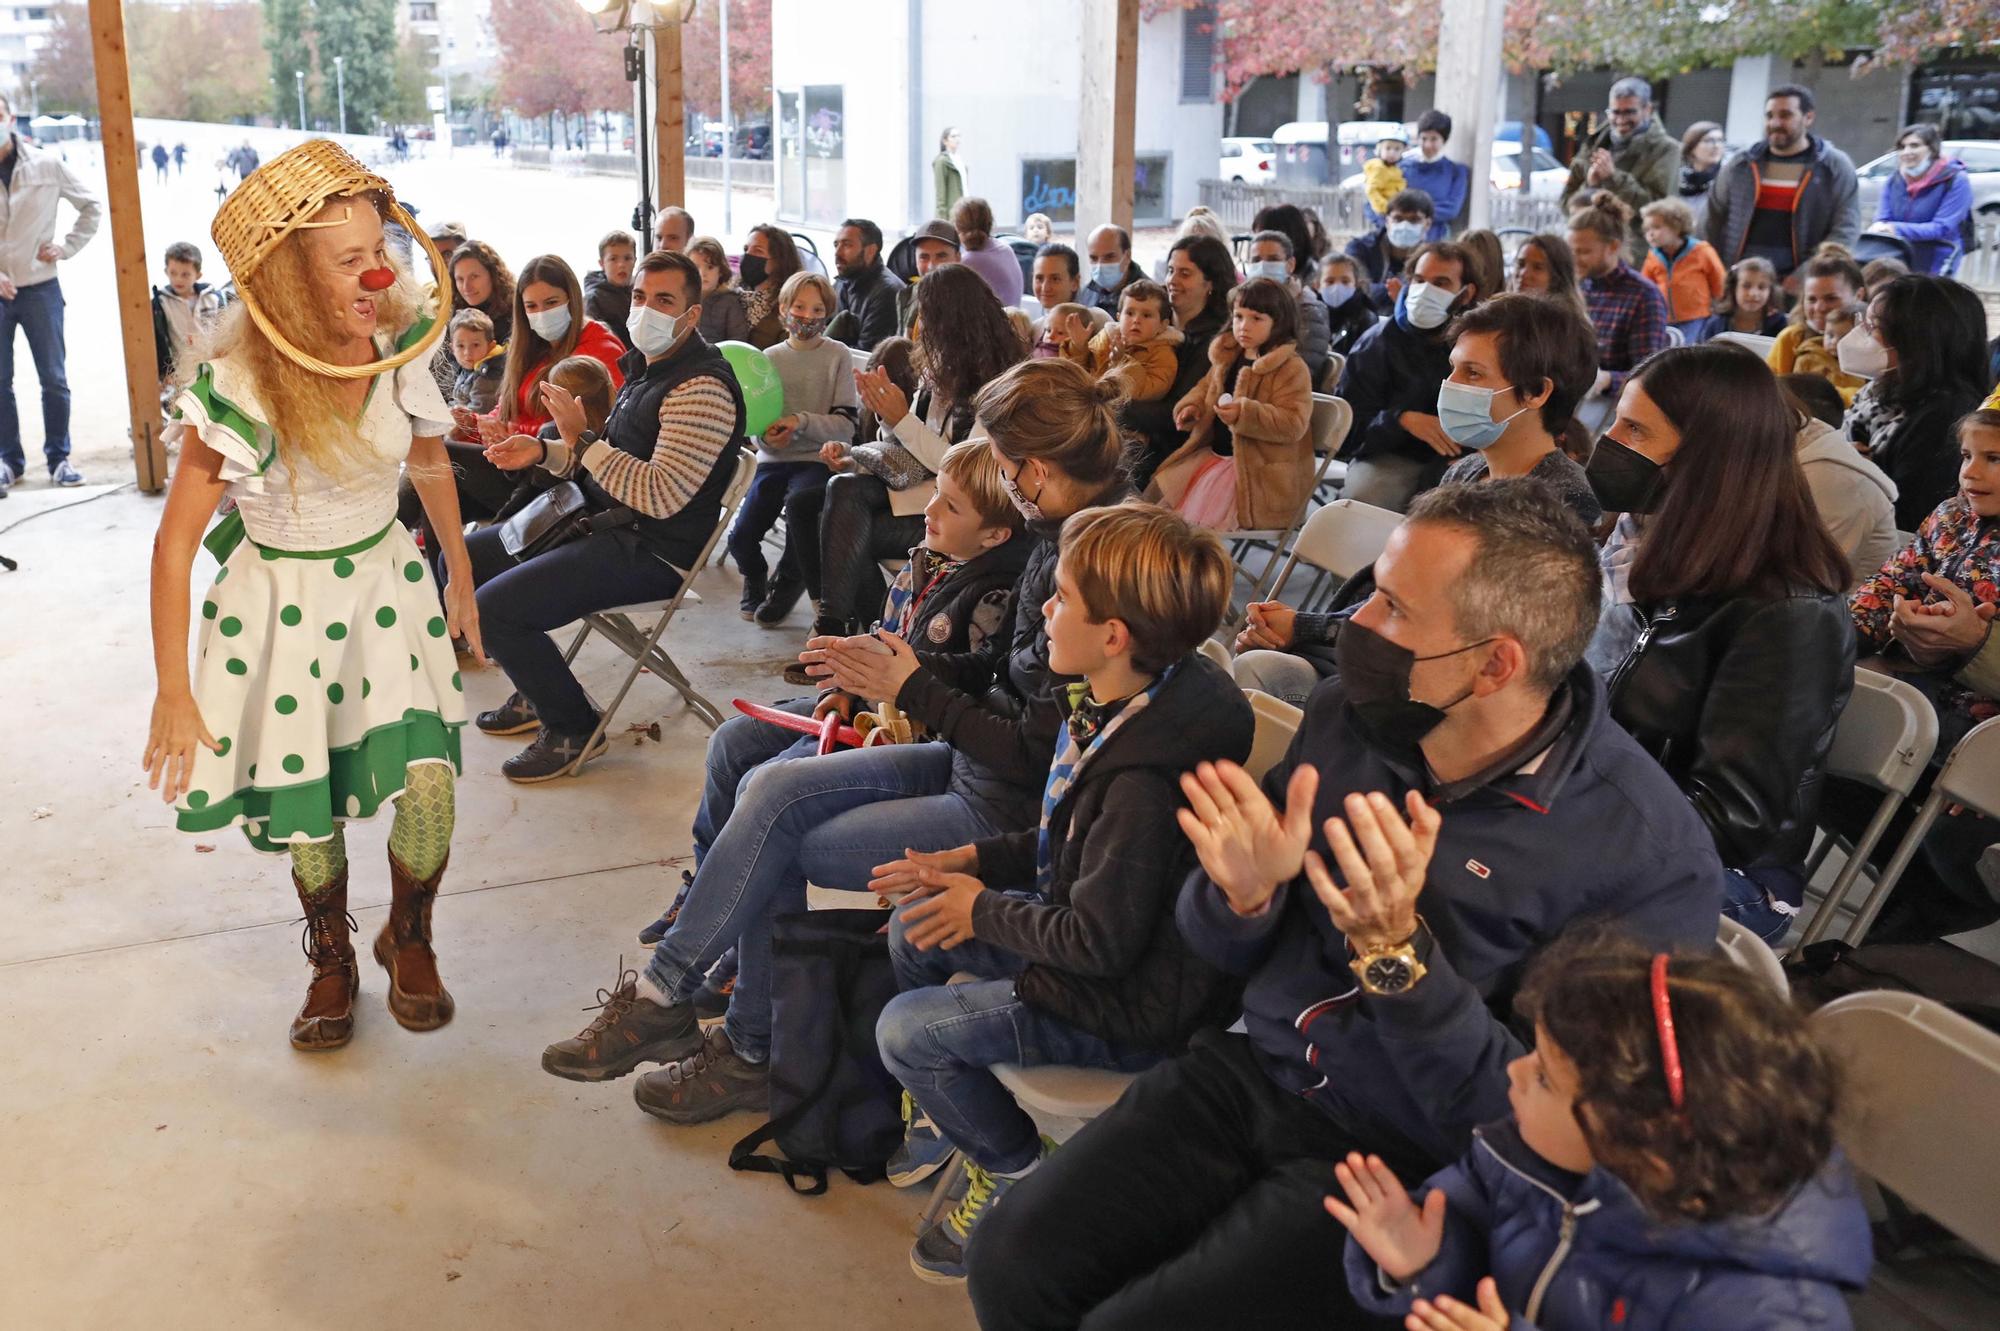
876;909;1160;1173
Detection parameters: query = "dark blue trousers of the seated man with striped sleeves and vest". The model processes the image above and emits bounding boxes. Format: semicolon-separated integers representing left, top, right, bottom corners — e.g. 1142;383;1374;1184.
466;528;680;739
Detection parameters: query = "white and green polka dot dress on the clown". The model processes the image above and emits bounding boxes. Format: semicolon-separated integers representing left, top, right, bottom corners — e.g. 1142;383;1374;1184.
170;325;466;853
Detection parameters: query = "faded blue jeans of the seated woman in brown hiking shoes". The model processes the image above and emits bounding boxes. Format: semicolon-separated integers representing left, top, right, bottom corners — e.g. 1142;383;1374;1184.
646;743;1010;1061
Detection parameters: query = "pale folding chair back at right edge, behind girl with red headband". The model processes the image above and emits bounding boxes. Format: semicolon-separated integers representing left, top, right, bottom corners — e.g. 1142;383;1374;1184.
1808;989;2000;1261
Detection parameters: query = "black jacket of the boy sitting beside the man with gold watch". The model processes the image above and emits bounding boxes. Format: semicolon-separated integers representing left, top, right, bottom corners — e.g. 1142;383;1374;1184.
972;654;1256;1053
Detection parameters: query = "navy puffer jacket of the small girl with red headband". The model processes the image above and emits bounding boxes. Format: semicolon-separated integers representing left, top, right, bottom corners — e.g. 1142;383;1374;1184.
1346;1119;1874;1331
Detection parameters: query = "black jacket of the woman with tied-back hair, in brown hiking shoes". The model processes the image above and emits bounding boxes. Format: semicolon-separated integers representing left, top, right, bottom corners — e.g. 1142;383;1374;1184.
896;480;1132;827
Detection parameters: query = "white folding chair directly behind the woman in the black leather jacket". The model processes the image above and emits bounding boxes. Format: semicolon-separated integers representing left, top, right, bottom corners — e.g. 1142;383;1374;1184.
1798;669;1938;947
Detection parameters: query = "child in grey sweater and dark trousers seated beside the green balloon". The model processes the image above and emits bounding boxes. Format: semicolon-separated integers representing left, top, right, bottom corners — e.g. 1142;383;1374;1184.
728;272;860;628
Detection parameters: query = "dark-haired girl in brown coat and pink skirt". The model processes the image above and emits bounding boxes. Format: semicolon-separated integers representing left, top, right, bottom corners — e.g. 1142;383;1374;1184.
1146;278;1312;532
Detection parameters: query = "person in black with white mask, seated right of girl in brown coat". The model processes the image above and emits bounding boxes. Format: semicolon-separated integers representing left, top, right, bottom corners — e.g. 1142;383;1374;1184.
1340;242;1480;514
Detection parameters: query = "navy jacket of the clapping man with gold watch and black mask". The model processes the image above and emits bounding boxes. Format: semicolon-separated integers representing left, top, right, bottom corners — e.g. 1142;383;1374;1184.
1178;664;1722;1169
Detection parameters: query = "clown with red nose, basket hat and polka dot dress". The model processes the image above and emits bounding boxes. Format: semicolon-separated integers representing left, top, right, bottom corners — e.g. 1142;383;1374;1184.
144;140;484;1049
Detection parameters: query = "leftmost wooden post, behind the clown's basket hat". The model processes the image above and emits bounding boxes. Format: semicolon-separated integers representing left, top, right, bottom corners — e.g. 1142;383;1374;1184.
90;0;166;494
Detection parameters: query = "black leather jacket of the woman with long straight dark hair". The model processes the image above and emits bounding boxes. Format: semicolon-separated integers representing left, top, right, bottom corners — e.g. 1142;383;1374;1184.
1608;590;1854;869
